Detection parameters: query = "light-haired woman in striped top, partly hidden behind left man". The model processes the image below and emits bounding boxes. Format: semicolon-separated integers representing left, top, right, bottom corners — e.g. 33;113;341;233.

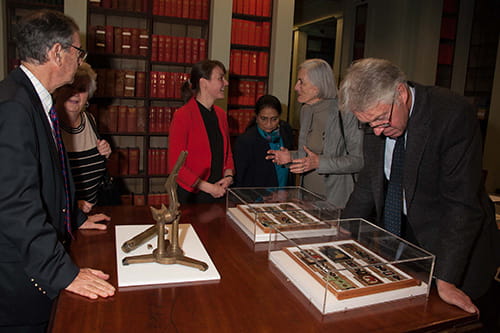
54;63;111;213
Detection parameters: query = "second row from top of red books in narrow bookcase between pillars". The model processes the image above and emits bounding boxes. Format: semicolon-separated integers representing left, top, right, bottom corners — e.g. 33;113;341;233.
231;19;271;47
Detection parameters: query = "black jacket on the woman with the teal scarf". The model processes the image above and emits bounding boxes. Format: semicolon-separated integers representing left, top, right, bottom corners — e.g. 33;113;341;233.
233;121;293;187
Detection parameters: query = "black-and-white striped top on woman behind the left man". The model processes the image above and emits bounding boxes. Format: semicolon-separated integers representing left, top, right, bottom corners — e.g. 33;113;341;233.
61;112;106;204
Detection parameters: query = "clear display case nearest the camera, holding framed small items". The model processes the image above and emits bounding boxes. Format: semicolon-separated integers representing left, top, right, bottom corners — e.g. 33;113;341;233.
269;219;435;314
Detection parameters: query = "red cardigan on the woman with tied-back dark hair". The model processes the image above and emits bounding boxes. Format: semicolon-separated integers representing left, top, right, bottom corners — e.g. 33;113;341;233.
168;98;234;192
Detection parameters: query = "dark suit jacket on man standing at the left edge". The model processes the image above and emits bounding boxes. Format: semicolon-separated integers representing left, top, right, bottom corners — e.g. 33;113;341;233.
0;69;85;326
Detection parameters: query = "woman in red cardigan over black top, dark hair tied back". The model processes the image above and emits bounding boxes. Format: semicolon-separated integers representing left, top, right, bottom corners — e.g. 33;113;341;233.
168;60;234;203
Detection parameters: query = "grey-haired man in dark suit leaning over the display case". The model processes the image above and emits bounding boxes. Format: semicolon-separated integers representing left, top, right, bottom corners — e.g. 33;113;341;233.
339;58;500;330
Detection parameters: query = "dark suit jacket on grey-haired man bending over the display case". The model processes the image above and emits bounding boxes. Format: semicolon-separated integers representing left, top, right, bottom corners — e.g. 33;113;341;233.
343;84;500;298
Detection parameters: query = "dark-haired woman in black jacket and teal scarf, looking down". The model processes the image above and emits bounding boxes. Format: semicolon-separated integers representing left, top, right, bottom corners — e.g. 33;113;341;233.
234;95;293;187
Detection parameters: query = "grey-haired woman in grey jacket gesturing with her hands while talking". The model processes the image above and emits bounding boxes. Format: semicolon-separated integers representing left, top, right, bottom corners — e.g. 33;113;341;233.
267;59;363;207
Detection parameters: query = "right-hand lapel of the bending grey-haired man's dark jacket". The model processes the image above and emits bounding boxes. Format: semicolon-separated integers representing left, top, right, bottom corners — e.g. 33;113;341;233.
403;85;431;207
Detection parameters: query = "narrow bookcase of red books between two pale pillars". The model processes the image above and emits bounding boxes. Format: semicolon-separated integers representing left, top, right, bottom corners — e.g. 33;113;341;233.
228;0;273;136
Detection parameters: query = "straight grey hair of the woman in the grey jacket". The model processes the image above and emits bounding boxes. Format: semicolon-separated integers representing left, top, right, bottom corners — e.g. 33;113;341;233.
299;59;337;99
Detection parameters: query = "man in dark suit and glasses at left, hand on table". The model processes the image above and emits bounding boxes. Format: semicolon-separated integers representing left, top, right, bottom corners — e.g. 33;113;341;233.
0;11;115;332
